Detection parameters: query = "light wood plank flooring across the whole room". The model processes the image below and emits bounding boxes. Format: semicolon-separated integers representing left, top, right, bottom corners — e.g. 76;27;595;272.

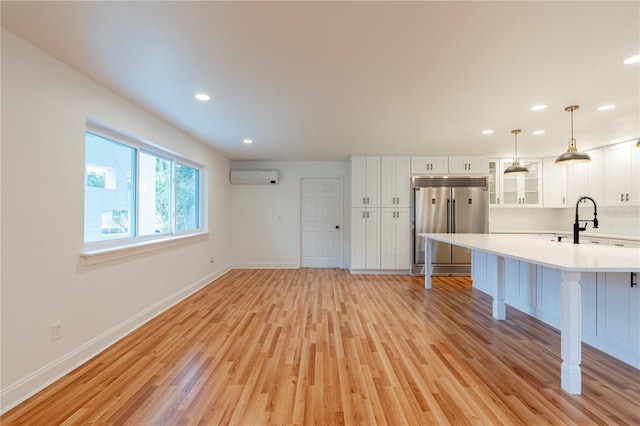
0;269;640;425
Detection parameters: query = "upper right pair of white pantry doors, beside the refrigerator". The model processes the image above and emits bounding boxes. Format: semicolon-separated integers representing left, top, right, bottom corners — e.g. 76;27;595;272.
380;157;411;207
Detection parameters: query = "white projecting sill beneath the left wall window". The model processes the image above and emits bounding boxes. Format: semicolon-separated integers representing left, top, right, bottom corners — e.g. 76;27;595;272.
80;232;209;266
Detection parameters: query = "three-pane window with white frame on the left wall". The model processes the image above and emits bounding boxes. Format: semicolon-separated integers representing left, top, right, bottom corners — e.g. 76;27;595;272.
84;126;202;247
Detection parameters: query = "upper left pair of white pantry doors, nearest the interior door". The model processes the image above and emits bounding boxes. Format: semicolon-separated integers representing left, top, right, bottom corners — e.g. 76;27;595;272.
351;157;380;207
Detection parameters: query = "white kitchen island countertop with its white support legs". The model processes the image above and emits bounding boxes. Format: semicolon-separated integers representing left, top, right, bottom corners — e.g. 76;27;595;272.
420;234;640;394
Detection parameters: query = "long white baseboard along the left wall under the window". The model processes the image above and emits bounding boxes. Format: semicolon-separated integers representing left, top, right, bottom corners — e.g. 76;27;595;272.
0;266;231;414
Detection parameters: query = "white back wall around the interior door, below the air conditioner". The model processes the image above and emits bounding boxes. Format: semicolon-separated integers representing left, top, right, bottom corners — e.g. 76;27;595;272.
231;160;351;268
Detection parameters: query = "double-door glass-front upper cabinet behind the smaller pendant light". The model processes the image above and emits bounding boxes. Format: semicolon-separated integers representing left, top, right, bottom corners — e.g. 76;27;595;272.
500;159;542;207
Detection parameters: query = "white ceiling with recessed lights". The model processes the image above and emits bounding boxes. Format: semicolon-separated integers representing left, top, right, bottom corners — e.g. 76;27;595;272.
1;1;640;160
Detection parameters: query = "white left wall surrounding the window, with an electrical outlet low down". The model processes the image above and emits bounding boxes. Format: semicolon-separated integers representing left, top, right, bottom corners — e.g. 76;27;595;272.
0;30;231;411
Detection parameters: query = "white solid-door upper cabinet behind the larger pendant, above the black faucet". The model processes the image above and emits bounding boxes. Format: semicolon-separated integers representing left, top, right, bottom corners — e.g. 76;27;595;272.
559;148;604;207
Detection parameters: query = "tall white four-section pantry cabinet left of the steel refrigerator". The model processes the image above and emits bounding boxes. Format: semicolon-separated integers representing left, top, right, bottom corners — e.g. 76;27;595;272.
351;157;411;270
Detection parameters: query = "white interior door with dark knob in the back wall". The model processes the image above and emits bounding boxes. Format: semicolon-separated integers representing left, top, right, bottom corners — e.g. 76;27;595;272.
301;178;342;268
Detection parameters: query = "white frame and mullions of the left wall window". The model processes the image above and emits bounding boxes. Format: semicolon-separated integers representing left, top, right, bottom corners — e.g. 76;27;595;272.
81;121;208;256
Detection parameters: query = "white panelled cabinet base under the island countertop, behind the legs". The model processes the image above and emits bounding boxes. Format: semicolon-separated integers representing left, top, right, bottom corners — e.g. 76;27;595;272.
471;255;640;368
